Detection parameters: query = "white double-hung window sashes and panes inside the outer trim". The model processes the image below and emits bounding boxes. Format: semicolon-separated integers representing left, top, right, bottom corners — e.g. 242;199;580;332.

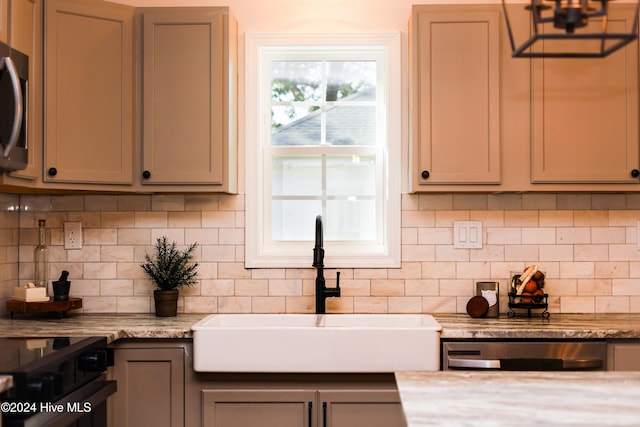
247;34;399;268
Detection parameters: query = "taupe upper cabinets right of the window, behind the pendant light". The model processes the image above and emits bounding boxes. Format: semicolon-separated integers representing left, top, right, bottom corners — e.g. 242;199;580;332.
409;4;640;192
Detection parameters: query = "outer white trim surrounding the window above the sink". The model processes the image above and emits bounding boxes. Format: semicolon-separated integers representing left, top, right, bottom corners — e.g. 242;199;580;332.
245;32;402;268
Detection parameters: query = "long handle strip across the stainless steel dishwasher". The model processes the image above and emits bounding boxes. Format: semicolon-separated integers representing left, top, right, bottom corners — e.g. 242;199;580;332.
448;359;603;371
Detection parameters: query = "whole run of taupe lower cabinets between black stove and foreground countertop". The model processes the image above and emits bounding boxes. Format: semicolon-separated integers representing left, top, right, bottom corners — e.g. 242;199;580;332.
108;339;406;427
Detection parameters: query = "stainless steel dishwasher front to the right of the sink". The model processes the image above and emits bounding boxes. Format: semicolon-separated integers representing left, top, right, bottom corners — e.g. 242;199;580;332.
442;340;607;371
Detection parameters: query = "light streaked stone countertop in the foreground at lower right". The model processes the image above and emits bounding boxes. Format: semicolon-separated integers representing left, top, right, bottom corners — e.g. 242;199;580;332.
396;371;640;427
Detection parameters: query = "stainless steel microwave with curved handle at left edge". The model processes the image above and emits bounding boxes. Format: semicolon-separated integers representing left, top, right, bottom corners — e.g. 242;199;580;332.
0;43;29;173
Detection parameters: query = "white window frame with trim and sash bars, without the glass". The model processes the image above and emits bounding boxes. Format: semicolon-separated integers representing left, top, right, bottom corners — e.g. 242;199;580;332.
245;33;401;268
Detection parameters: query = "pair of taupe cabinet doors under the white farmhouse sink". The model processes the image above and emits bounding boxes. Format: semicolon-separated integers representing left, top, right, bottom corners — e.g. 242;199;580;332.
202;384;406;427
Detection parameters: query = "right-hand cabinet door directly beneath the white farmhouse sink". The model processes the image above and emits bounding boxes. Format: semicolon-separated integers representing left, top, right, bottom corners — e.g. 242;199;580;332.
318;390;406;427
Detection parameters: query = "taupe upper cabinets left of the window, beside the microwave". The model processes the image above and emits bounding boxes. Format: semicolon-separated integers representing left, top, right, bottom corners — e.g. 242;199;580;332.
5;0;238;193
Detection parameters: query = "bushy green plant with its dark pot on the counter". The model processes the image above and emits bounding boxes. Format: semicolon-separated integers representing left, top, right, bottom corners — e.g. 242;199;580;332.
140;236;198;317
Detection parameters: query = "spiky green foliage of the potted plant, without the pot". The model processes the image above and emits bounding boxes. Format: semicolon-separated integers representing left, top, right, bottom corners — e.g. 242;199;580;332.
140;236;198;291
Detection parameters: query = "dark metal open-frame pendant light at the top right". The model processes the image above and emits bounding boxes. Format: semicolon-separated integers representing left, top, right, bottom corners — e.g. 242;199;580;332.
502;0;640;58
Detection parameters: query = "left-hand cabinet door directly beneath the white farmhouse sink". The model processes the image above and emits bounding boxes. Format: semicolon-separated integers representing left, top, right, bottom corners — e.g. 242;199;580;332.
202;389;316;427
